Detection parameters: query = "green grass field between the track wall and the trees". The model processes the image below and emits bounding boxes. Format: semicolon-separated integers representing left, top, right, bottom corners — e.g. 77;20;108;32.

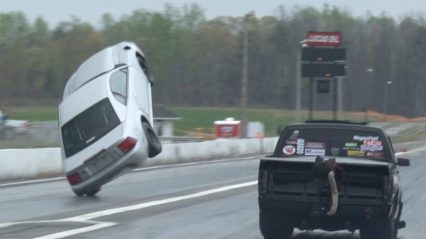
0;106;377;136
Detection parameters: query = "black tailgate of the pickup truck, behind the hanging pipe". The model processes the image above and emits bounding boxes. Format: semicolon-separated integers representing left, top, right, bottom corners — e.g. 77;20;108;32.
259;157;390;205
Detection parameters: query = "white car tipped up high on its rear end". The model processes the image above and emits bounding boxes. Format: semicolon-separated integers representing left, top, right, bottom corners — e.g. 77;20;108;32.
59;42;162;196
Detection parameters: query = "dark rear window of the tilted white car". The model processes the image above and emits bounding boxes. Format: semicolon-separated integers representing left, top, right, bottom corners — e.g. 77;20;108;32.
61;99;120;158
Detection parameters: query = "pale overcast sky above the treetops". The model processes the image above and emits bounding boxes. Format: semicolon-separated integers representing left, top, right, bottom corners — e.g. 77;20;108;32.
0;0;426;27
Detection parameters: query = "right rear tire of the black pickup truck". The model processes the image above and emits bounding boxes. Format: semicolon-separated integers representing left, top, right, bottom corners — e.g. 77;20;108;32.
360;218;396;239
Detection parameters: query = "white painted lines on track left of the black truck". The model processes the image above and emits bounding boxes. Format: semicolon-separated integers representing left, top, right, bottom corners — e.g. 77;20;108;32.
0;181;257;239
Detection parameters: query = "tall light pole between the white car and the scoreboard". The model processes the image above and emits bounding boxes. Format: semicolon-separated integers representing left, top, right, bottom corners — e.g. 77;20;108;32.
241;11;254;138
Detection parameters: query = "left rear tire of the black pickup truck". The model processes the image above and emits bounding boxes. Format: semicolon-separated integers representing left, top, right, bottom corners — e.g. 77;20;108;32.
259;211;294;239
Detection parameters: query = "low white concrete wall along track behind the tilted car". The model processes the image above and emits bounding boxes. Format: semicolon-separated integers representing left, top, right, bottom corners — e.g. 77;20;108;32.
0;138;277;180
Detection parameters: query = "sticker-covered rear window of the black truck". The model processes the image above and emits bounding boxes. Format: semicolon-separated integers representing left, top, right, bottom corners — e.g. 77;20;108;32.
274;128;386;160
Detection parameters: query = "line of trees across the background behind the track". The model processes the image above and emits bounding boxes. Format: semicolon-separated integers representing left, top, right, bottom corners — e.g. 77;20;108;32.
0;4;426;116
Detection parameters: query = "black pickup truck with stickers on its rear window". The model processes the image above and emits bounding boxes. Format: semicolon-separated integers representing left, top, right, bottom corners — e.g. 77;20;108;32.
258;121;410;239
